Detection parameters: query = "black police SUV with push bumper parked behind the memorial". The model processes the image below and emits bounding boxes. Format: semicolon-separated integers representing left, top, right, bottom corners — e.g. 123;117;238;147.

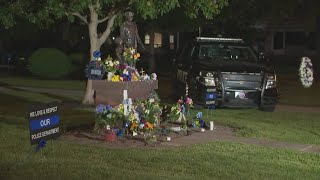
172;37;278;111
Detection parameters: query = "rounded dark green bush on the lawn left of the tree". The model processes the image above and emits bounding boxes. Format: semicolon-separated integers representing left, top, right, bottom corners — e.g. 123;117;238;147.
28;48;72;79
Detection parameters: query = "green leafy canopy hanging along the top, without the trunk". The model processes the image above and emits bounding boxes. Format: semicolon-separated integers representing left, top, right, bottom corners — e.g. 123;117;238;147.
0;0;228;27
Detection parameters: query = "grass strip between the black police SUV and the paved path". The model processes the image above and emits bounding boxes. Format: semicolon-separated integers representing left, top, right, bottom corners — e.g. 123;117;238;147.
208;109;320;145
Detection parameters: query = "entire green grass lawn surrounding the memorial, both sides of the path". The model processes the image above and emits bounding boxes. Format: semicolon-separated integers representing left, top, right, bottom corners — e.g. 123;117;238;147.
0;74;320;179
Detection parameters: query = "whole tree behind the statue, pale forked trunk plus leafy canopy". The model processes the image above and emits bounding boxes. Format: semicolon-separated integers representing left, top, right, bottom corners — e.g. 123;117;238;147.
0;0;228;104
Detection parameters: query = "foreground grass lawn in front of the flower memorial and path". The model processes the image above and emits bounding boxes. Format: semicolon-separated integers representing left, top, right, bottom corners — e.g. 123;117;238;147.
0;127;320;179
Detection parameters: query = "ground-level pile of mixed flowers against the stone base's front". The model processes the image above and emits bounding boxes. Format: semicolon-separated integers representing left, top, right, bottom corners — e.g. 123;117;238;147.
94;93;162;138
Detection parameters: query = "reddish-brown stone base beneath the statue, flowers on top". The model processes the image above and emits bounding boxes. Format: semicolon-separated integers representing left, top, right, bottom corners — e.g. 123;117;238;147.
92;80;158;106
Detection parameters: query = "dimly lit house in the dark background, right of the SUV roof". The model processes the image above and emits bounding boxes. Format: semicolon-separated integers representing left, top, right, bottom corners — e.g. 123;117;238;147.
254;18;317;56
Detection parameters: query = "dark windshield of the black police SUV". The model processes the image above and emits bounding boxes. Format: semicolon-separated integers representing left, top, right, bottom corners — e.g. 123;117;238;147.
199;44;257;62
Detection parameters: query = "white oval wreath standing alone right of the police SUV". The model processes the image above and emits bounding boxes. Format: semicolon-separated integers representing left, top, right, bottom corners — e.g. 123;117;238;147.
299;57;313;88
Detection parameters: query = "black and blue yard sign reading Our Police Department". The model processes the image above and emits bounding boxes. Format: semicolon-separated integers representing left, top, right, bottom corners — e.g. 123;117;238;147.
28;103;60;144
